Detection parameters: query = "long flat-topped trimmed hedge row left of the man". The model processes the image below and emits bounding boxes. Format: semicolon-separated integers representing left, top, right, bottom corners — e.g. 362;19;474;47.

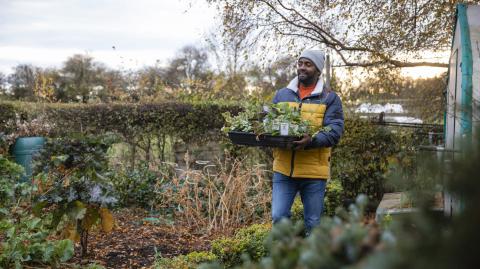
0;102;241;142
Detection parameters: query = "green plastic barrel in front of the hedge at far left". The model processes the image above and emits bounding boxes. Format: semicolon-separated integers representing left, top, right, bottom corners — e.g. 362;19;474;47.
12;136;45;181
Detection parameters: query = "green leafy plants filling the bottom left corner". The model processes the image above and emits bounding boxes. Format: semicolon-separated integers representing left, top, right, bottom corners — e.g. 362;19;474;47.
0;154;73;268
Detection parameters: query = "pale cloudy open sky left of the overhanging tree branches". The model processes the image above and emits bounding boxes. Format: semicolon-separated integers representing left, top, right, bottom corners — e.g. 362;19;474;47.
0;0;215;74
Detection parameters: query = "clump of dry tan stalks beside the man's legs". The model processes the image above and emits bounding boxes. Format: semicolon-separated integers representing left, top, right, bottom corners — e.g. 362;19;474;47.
158;154;271;232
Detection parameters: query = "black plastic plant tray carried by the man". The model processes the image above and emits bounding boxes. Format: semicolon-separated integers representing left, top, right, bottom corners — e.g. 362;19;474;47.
228;132;302;148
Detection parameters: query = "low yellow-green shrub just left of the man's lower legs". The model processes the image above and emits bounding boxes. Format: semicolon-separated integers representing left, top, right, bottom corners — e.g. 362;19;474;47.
212;224;271;267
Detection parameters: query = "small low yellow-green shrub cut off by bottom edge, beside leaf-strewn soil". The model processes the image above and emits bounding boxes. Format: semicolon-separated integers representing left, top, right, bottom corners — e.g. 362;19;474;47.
153;251;217;269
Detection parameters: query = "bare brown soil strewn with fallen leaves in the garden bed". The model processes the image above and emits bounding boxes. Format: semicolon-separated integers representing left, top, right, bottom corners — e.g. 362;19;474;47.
69;209;213;269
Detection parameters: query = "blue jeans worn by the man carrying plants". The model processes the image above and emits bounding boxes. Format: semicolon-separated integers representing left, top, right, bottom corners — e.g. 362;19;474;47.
272;172;326;233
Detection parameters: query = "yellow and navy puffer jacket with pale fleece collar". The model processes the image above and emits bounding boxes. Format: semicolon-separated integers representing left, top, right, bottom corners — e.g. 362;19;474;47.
272;78;344;179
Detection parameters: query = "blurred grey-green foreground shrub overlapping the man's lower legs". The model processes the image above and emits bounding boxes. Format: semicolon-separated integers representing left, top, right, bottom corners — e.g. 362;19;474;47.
202;195;380;269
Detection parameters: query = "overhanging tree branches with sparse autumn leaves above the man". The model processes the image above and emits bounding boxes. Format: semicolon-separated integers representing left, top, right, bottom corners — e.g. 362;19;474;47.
206;0;480;67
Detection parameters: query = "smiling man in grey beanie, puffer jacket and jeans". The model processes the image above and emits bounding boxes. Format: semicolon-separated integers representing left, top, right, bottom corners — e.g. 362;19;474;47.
272;50;344;234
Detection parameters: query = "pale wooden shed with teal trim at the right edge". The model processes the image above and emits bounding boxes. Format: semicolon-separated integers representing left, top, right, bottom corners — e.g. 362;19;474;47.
444;4;480;215
